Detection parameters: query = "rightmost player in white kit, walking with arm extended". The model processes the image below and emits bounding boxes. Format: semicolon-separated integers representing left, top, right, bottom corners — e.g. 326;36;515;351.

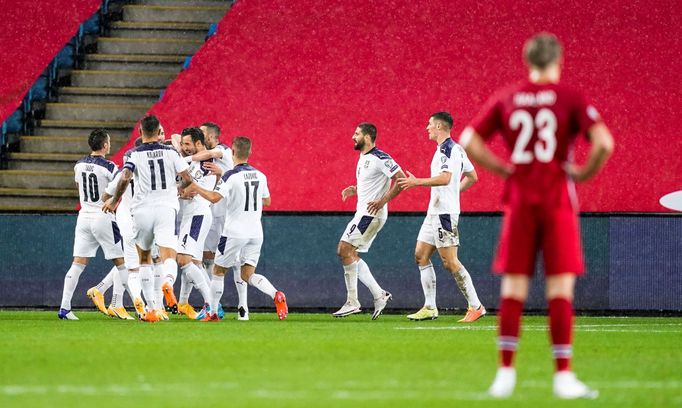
398;112;486;323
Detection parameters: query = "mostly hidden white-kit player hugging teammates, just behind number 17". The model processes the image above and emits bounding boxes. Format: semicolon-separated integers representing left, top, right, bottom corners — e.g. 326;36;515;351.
192;122;249;320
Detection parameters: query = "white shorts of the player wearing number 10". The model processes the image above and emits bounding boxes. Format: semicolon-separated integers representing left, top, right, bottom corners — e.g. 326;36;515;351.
73;213;123;259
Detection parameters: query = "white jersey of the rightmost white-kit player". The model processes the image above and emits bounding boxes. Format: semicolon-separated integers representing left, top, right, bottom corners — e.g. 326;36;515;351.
426;138;474;215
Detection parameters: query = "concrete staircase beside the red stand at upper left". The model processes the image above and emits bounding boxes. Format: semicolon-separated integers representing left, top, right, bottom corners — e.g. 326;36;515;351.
0;0;232;212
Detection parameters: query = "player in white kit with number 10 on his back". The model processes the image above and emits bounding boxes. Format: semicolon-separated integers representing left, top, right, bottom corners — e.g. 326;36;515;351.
57;129;125;320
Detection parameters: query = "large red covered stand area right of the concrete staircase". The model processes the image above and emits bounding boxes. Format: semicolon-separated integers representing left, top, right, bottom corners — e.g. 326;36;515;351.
109;0;682;211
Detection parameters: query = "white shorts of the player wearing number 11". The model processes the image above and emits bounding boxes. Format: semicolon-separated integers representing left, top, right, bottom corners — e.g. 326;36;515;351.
133;206;178;251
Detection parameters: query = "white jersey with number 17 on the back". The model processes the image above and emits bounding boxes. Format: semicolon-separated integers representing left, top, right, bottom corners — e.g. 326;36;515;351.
216;163;270;238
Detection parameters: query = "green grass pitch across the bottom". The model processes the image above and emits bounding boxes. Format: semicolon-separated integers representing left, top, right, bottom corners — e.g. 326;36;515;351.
0;311;682;408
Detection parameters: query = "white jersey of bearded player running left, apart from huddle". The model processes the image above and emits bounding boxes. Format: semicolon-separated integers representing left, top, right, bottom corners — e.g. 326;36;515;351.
355;147;400;219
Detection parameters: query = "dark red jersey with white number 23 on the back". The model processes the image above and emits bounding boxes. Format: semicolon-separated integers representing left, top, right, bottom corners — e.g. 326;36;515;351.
471;81;601;209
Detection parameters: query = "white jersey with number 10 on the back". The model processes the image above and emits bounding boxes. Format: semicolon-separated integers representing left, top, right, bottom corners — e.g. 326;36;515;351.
73;156;118;214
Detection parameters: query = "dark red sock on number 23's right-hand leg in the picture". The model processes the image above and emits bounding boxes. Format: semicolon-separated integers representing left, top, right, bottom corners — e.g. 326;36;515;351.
549;298;573;371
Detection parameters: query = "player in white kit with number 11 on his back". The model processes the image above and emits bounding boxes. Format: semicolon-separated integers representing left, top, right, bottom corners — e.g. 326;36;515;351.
102;115;192;322
